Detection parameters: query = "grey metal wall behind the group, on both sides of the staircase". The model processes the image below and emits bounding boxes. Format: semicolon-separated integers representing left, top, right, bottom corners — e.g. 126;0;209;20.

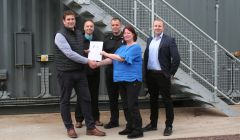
0;0;240;97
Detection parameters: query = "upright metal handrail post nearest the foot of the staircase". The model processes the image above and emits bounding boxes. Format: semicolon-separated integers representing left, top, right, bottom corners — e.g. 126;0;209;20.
213;41;218;102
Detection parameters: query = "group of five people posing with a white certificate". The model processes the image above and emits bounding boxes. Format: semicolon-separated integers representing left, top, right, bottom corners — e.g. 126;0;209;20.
55;10;180;138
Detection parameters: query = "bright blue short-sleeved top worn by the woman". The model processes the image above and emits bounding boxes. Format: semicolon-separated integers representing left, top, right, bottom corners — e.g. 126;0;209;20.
113;44;142;82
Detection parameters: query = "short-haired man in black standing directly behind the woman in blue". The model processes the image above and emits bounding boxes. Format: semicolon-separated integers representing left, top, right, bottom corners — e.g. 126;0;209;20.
103;18;123;129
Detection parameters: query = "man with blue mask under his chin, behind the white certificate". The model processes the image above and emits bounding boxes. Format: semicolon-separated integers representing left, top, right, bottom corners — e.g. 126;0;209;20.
75;19;103;128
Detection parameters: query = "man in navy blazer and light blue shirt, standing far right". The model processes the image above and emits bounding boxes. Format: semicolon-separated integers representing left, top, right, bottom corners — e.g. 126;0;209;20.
143;19;180;136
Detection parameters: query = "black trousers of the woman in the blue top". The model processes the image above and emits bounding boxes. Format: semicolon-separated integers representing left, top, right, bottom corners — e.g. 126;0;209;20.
118;81;142;131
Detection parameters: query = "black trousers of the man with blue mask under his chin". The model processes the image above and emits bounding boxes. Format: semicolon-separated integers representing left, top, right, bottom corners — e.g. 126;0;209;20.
75;71;100;122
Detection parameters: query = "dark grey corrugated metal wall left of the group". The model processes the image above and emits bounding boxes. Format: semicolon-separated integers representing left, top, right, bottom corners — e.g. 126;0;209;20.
0;0;63;97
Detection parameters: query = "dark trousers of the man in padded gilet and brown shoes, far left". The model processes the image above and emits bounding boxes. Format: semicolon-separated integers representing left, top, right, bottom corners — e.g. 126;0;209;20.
57;71;95;129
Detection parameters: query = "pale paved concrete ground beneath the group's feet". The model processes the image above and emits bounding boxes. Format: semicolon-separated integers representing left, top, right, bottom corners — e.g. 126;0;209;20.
0;105;240;140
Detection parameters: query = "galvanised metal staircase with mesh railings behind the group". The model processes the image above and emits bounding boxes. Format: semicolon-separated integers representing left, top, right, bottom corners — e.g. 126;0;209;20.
62;0;240;116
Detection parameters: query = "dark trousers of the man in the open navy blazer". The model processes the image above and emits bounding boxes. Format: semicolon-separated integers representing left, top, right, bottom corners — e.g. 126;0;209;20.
147;71;174;127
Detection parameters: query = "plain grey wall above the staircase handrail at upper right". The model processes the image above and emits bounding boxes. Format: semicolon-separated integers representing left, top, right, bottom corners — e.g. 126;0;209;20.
166;0;240;52
